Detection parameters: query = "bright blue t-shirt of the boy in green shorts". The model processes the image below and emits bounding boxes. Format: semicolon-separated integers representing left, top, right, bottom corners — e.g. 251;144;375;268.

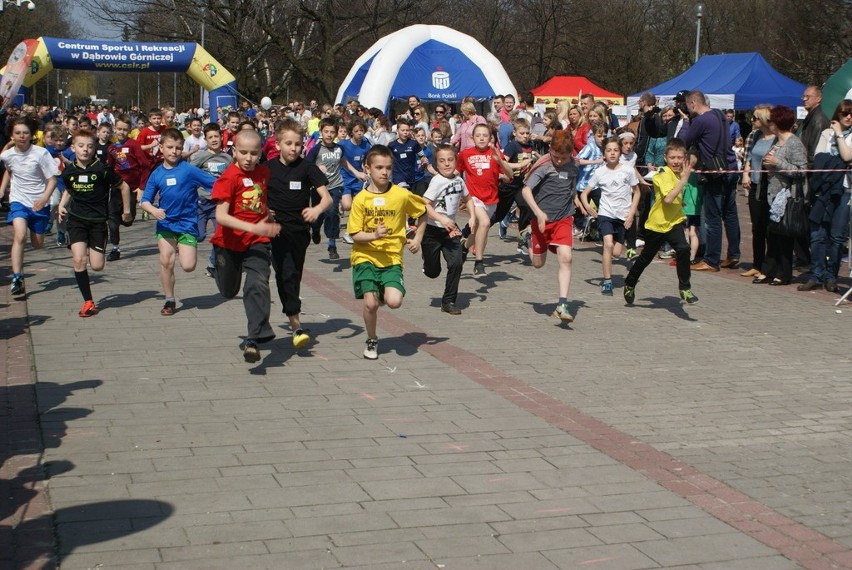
141;160;216;237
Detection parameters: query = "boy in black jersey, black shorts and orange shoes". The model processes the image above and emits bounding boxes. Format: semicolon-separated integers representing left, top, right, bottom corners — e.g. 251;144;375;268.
58;130;131;318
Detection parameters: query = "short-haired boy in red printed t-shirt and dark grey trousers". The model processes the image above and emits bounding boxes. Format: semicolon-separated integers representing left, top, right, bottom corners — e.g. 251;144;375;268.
210;130;281;362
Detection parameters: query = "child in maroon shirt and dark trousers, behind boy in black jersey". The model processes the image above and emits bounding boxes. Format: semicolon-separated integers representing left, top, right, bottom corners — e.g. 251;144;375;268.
107;115;151;261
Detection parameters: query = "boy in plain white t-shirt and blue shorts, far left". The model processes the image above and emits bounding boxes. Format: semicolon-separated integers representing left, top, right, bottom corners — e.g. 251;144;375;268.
0;117;59;295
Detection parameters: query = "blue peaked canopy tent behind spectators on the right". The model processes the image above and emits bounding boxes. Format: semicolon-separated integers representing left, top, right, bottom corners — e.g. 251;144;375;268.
627;53;805;111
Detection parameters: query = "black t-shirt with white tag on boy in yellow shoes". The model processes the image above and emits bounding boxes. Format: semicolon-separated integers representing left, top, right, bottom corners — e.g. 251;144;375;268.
266;157;328;230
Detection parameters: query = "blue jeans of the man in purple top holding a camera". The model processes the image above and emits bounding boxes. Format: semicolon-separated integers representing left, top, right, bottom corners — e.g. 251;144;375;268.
701;174;740;267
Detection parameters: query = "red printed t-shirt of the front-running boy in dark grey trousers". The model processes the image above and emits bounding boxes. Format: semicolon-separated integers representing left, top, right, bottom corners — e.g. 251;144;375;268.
210;160;269;251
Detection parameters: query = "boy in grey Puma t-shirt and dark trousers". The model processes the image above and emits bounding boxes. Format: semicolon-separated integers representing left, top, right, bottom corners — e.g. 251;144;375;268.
305;117;343;259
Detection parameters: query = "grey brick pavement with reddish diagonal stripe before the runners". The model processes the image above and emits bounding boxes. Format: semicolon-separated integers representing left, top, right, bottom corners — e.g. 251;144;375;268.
0;211;852;570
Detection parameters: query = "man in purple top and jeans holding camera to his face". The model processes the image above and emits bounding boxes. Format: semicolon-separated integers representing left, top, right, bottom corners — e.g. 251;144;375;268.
678;91;740;271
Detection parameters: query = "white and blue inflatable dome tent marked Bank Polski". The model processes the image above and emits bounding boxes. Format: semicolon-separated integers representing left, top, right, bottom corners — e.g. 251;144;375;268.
337;24;517;110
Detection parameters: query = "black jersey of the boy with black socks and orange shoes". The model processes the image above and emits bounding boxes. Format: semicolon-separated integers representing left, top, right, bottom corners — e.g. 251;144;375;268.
62;159;123;222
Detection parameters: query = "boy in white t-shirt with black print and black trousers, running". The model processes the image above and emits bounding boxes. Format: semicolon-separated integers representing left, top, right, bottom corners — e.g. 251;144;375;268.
417;141;470;315
